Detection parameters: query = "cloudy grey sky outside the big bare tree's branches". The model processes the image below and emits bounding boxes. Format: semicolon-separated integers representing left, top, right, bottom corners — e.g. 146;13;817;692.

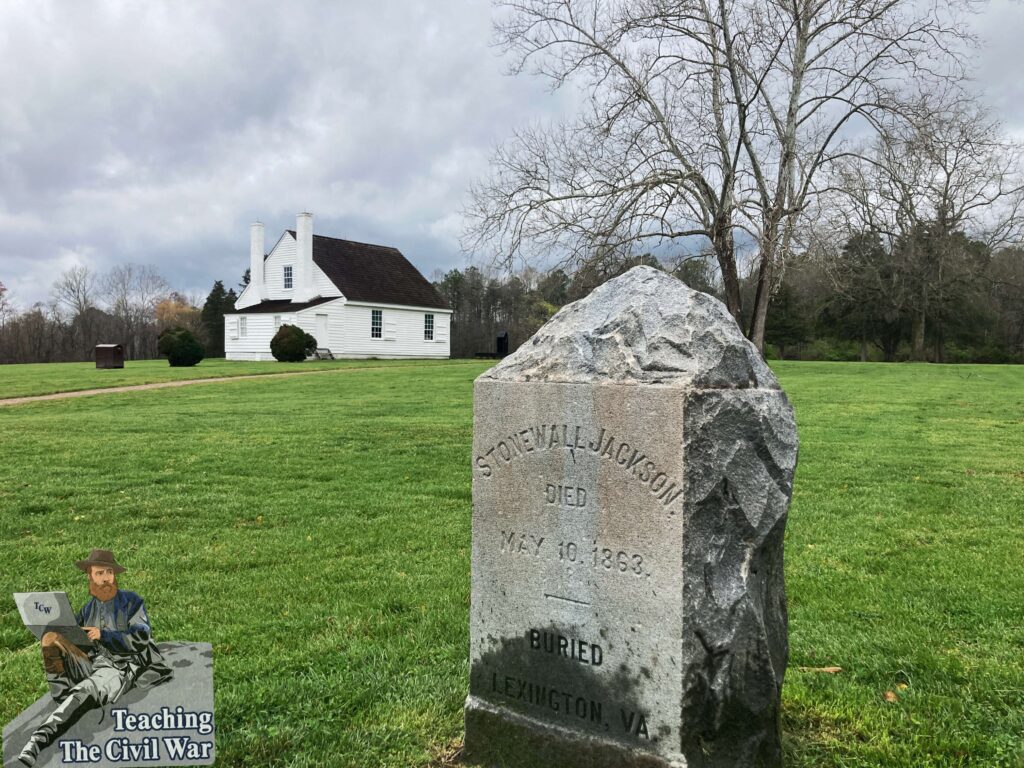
0;0;1024;307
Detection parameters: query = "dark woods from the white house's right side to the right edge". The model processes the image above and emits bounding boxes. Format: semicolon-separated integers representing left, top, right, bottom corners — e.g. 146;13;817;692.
434;240;1024;362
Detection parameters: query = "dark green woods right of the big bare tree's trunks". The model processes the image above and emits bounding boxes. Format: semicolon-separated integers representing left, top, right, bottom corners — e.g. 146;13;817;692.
766;244;1024;362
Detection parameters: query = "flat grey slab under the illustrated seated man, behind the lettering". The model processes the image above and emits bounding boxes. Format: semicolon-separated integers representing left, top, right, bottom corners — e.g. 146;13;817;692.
3;641;216;768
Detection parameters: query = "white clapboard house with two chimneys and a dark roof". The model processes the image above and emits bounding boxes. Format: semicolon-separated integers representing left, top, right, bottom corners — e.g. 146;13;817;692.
224;213;452;360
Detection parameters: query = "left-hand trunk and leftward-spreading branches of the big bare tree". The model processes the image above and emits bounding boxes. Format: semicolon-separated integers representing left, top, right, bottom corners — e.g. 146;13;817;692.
464;0;741;319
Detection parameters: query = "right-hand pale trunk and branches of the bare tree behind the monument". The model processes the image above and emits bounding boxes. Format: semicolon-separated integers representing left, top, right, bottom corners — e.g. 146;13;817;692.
717;0;967;349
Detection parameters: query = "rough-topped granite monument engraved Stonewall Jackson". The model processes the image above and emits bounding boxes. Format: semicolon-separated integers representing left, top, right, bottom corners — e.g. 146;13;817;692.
466;267;797;768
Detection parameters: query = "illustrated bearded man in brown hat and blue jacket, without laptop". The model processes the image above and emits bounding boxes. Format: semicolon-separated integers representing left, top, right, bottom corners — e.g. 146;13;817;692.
18;549;172;766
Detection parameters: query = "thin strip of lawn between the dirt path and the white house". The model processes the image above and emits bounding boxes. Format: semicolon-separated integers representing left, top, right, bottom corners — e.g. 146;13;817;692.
0;358;460;399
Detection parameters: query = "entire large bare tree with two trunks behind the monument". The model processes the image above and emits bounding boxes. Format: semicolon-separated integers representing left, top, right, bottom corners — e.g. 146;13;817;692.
464;0;967;349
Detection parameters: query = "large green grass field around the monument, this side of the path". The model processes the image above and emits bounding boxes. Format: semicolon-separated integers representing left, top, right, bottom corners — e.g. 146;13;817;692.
0;362;1024;768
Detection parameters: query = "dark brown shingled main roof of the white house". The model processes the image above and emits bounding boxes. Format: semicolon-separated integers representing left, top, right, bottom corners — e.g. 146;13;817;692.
288;229;449;309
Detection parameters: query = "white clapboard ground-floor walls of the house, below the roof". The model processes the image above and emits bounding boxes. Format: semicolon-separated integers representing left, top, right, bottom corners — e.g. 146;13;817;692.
224;301;452;360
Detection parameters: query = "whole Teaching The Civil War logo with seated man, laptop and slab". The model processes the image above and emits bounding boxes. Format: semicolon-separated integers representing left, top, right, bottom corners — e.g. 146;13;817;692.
4;549;213;768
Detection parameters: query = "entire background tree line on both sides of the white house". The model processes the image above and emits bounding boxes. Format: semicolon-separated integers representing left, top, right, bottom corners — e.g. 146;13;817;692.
0;237;1024;362
